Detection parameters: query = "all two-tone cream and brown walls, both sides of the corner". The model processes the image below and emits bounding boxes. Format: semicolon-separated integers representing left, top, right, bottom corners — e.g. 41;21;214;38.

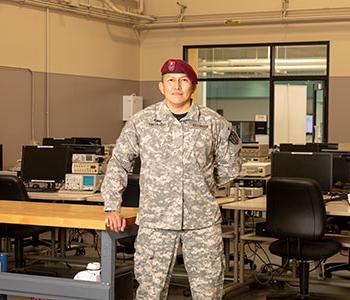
0;0;350;167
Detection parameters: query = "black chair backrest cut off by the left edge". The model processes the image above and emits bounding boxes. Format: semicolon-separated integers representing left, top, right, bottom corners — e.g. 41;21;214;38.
0;175;28;200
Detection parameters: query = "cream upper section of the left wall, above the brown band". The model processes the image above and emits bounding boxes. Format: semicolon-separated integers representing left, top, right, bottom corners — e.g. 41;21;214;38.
0;3;140;80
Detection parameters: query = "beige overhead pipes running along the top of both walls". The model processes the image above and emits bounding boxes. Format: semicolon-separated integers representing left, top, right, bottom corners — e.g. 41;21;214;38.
10;0;350;31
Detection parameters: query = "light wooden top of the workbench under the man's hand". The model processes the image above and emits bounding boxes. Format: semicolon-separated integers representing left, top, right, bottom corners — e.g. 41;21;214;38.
0;200;137;230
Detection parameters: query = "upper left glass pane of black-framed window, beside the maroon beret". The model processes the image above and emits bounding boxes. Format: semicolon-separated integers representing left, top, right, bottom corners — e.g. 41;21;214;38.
189;46;270;79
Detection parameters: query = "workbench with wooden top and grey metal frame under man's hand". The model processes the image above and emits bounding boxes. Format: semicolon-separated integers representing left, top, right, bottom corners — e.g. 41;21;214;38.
0;200;137;300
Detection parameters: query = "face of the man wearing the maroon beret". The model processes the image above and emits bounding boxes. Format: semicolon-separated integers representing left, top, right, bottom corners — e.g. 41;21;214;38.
159;73;196;107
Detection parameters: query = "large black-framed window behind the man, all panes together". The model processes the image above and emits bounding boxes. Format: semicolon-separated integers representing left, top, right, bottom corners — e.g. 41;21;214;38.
184;42;329;146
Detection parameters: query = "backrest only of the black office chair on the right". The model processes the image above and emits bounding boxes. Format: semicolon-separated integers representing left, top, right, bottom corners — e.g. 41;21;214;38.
266;177;326;240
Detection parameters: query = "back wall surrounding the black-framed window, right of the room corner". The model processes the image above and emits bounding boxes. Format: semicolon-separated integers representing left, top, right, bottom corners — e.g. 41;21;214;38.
140;0;350;142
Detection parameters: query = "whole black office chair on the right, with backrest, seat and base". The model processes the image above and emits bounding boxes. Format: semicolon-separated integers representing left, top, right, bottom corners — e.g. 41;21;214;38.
266;177;341;299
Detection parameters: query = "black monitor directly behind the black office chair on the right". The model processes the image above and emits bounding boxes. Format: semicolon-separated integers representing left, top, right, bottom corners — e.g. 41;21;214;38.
271;152;333;193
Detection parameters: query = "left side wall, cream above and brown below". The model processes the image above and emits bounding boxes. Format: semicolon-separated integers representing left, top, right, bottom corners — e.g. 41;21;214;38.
0;3;140;168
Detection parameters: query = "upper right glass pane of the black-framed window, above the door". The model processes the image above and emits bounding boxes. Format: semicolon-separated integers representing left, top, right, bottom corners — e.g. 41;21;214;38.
274;45;327;76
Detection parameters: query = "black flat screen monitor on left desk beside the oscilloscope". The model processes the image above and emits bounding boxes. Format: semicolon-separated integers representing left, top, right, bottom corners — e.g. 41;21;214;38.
21;146;69;183
